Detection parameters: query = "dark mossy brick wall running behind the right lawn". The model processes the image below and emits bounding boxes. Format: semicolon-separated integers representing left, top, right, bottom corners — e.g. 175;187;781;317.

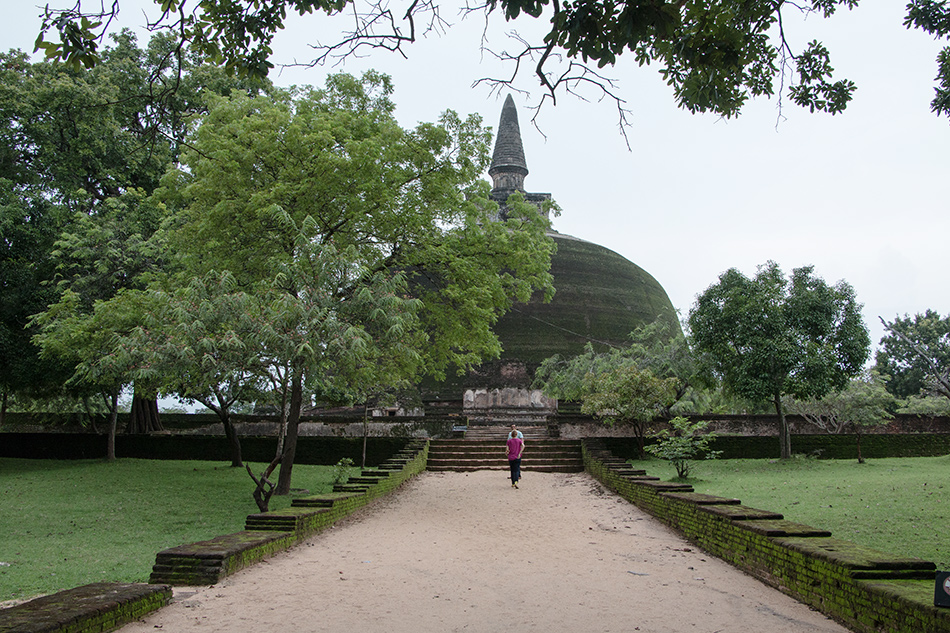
604;433;950;459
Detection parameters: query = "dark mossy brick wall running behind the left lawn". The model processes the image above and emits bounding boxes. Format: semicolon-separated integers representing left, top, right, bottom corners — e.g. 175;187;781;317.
0;433;411;466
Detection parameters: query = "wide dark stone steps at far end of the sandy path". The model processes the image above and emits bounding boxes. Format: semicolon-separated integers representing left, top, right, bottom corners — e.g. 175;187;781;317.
426;436;584;473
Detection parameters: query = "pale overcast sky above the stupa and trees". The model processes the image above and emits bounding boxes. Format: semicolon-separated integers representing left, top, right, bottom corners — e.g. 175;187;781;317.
7;0;950;354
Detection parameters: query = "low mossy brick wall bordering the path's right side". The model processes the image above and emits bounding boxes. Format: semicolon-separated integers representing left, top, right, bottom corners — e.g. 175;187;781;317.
583;440;950;633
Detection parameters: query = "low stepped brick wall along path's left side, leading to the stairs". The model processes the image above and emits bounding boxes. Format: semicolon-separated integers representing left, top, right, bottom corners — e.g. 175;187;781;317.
149;440;429;586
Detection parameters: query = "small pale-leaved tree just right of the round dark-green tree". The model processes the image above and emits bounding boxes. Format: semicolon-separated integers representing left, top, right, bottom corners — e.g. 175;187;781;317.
787;370;897;464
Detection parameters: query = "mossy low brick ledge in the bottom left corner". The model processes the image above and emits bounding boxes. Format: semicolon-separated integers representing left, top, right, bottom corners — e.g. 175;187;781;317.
0;582;172;633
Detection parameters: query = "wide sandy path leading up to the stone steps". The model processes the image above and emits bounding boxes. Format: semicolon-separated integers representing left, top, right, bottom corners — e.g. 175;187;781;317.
121;471;846;633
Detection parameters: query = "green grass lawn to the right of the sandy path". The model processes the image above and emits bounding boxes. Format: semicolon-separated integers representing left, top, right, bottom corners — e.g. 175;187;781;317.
633;456;950;570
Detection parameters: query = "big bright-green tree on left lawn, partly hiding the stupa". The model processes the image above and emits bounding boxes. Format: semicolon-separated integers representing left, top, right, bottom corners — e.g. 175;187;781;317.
164;73;553;493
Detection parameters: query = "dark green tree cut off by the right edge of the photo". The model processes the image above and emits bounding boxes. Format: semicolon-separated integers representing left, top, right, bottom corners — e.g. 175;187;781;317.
874;310;950;398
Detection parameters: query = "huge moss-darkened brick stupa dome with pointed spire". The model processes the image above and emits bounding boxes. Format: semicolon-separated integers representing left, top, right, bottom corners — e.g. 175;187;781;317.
423;95;679;422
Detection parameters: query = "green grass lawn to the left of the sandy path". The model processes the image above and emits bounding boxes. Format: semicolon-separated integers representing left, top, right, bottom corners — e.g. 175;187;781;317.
0;459;336;602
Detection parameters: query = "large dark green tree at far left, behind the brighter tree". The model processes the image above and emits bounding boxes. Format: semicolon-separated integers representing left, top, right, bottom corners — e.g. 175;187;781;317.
10;31;265;424
